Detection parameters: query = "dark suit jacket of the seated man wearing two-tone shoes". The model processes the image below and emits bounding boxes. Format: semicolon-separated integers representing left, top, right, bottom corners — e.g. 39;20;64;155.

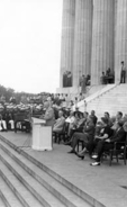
110;127;126;142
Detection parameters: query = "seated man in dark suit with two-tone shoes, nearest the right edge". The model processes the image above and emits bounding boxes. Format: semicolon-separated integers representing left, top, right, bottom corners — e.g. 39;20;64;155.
91;121;127;166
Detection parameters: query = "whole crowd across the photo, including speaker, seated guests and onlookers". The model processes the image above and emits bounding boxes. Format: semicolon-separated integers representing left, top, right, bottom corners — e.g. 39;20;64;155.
0;94;127;166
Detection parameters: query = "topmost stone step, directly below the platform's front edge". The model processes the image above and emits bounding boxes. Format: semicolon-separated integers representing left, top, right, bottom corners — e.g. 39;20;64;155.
0;135;104;207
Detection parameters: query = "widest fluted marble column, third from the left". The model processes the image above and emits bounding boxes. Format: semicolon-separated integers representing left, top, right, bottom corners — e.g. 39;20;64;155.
91;0;114;85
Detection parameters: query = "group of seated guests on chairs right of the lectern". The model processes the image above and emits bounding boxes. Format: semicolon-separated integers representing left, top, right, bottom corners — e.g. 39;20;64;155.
53;106;127;166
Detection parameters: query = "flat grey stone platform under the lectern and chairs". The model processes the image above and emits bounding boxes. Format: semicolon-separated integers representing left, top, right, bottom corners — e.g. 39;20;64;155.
0;132;127;207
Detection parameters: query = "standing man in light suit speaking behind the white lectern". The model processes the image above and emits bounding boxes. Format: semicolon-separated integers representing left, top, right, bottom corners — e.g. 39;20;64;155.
40;97;55;127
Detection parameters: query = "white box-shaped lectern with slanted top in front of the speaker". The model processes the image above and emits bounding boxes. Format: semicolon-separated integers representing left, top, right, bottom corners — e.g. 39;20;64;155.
32;117;52;151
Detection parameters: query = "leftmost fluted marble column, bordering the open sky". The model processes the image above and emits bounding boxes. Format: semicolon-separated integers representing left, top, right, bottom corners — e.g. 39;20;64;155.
60;0;75;88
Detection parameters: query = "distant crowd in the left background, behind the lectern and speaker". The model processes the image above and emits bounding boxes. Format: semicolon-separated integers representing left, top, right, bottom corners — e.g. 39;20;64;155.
0;93;78;131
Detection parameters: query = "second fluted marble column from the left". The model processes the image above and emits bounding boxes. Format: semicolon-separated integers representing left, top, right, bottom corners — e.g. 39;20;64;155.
73;0;93;87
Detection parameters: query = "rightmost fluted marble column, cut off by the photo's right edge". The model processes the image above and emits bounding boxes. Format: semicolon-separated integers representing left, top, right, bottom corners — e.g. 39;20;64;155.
115;0;127;83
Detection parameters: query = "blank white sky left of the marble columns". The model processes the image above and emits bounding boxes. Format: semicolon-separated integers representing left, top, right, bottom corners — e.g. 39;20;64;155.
0;0;63;93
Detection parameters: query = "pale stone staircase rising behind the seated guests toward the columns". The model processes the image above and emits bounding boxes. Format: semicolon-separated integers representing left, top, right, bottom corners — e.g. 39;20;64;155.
78;84;127;117
